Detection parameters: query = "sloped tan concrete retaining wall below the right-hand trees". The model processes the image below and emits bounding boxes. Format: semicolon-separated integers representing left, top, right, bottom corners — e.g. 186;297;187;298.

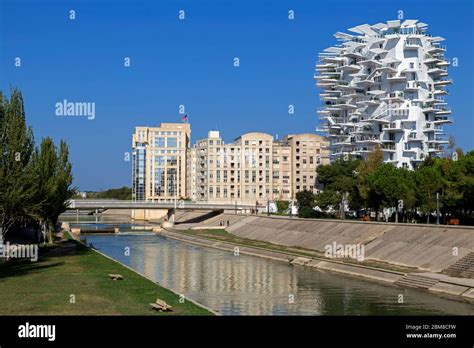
215;214;474;272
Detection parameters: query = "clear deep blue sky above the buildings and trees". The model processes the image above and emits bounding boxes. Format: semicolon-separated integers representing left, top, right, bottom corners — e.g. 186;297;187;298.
0;0;474;190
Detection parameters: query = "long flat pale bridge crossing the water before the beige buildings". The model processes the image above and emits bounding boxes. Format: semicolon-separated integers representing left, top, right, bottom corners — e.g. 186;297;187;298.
67;199;265;223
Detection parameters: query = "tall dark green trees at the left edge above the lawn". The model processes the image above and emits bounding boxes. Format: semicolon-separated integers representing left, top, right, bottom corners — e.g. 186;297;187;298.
0;89;74;241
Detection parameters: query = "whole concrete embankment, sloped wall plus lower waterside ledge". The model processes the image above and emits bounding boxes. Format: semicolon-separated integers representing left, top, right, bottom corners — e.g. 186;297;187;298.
164;214;474;299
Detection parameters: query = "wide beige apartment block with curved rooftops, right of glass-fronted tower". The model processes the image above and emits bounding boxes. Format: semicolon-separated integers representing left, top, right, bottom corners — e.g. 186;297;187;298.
188;131;329;204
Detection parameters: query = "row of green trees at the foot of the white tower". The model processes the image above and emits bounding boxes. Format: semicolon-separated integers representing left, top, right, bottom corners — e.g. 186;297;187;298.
296;148;474;224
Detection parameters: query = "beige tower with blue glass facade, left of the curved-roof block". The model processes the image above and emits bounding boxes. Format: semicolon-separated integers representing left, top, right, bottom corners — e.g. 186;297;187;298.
132;123;191;202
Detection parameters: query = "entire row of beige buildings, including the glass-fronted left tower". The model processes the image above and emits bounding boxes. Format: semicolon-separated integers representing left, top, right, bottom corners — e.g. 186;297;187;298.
133;123;329;205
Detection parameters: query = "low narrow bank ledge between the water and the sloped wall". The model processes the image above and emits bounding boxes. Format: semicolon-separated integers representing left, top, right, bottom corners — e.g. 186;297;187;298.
161;229;474;302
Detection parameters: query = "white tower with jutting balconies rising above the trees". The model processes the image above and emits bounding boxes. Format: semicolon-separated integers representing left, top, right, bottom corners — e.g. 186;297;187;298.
315;20;452;169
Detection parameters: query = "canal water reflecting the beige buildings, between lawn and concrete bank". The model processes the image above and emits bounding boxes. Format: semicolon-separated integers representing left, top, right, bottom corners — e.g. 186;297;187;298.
83;232;474;315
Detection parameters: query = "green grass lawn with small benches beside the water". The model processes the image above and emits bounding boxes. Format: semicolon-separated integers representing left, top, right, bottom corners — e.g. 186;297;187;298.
0;240;211;315
